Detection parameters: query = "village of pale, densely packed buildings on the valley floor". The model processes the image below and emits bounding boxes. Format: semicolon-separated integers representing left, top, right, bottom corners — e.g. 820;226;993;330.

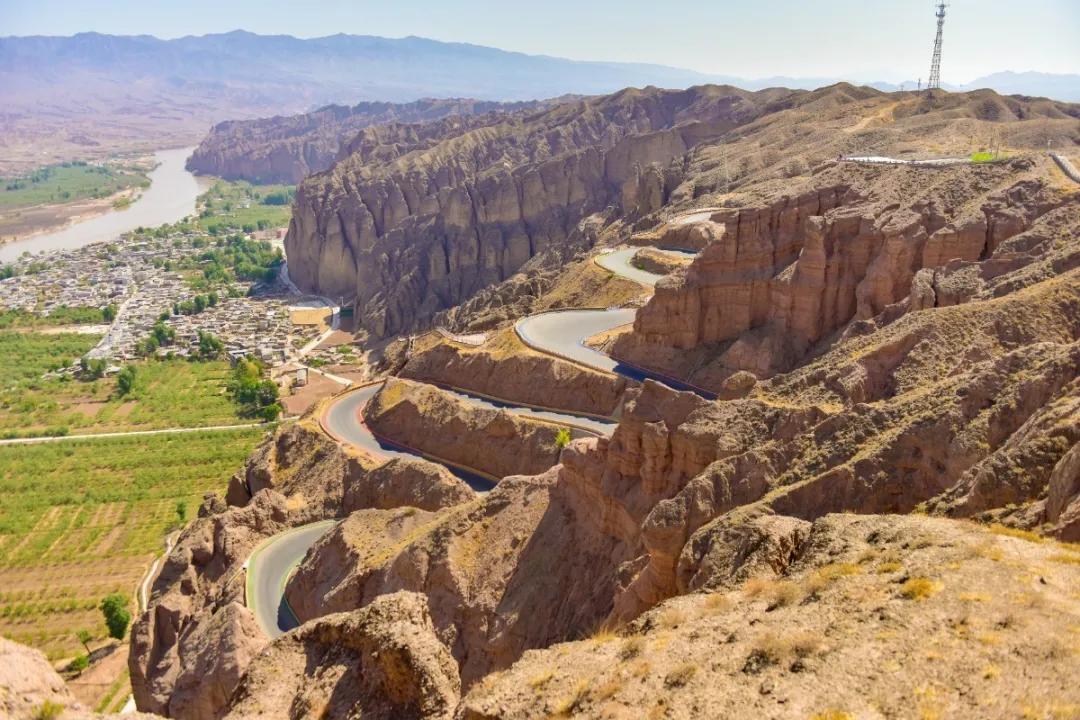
0;229;334;380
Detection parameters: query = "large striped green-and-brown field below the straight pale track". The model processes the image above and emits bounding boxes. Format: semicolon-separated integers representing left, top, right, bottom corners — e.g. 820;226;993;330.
0;429;266;660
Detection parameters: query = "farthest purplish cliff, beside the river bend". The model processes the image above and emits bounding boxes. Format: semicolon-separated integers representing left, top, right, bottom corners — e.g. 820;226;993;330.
187;98;542;185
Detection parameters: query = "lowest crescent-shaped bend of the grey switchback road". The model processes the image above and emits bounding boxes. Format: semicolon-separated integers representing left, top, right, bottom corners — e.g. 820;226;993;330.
247;520;337;639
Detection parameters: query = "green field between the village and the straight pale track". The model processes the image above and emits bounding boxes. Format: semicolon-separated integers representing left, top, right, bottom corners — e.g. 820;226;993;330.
0;341;251;437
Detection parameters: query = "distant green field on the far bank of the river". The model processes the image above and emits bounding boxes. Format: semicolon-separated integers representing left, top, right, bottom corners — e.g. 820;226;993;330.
0;162;150;210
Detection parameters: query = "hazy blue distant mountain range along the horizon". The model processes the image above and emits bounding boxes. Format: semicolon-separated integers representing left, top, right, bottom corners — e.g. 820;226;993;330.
0;30;1080;172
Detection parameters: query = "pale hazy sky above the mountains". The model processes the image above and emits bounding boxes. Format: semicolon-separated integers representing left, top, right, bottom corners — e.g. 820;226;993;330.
0;0;1080;83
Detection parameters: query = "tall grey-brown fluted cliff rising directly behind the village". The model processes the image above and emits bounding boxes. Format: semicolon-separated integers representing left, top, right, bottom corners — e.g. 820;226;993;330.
286;87;792;335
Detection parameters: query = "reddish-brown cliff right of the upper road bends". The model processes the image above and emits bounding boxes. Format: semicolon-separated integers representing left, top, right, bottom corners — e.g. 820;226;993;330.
613;167;1063;390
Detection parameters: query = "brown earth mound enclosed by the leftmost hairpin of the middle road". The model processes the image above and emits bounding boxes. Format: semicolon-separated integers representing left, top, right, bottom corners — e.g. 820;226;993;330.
364;378;559;478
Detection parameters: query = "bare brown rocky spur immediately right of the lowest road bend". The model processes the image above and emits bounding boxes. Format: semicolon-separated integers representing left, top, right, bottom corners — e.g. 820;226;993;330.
286;470;612;687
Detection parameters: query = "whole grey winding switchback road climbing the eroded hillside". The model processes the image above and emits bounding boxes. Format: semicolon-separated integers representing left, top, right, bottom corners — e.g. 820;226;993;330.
244;248;693;638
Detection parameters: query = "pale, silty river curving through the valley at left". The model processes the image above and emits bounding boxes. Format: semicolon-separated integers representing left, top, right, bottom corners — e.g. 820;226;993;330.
0;148;212;262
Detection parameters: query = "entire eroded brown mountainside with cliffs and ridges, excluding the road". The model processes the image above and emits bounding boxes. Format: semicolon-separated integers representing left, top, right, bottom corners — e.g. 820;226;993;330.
116;85;1080;720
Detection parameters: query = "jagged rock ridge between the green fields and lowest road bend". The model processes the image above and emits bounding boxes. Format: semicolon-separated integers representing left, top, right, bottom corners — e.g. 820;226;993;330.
129;422;474;720
